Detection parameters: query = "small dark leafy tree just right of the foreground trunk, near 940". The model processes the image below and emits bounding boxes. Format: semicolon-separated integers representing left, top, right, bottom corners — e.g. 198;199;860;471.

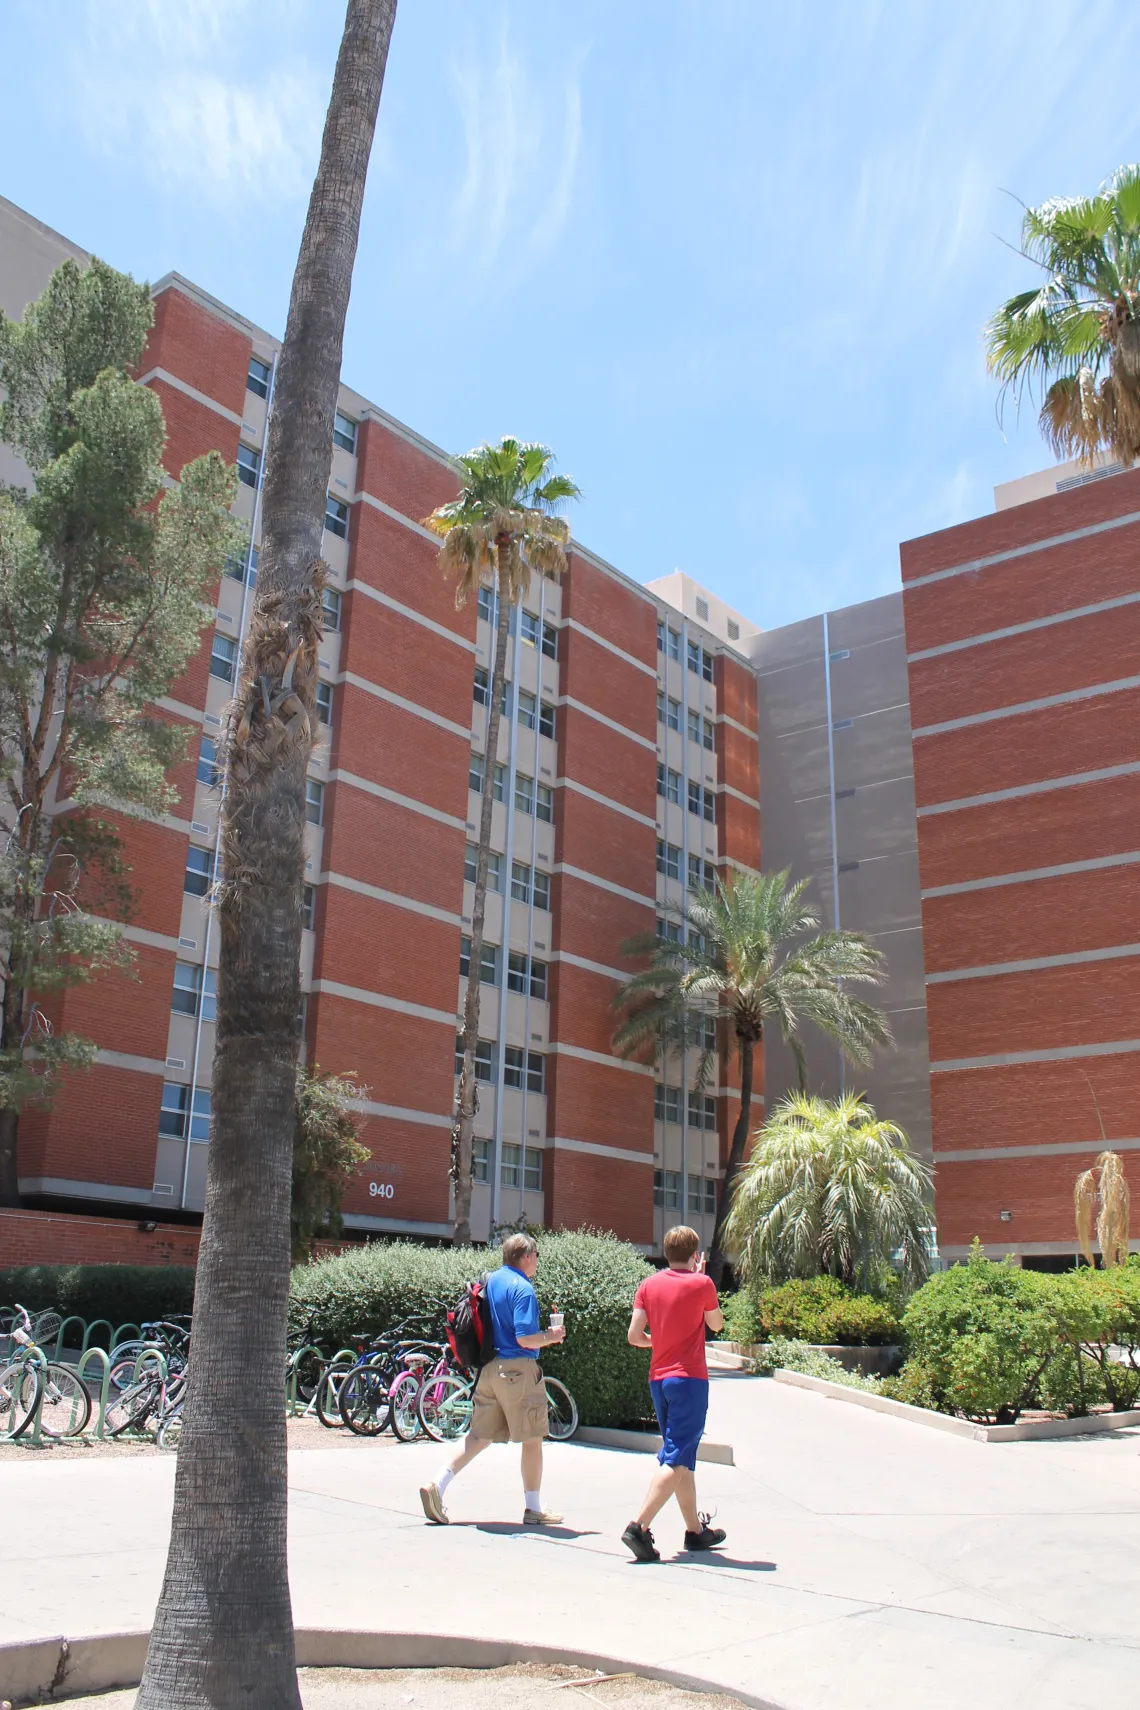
289;1065;373;1265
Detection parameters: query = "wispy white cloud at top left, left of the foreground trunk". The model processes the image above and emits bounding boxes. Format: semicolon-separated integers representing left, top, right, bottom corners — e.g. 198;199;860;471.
68;0;326;203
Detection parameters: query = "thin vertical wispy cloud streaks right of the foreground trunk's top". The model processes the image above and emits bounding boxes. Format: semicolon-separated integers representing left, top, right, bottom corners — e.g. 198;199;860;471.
450;27;583;287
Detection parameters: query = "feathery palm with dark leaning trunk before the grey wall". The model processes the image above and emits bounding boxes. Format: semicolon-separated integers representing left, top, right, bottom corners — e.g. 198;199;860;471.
614;869;892;1288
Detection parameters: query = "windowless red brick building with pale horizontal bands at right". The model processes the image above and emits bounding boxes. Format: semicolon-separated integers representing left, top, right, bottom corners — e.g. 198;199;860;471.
902;470;1140;1259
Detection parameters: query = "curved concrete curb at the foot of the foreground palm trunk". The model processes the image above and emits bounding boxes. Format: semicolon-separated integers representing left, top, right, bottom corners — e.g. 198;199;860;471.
0;1626;779;1710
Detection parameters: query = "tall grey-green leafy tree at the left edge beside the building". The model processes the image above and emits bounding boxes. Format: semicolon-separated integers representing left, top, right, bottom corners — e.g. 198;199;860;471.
0;262;236;1206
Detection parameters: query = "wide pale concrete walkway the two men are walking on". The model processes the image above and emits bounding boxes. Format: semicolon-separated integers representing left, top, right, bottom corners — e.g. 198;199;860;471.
0;1377;1140;1710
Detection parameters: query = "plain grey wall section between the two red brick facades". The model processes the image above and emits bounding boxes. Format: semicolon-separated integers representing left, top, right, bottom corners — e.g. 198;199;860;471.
750;593;931;1158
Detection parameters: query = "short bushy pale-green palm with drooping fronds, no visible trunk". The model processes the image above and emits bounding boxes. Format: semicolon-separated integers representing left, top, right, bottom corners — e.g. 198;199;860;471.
725;1093;933;1289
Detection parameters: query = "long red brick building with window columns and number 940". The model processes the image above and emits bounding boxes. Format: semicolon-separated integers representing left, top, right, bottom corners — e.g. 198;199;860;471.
0;205;761;1248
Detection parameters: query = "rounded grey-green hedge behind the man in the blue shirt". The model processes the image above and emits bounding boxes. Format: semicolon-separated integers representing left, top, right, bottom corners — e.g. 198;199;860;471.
291;1231;651;1424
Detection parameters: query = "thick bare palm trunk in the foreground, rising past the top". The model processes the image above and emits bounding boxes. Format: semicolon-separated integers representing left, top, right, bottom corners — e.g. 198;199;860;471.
137;0;397;1710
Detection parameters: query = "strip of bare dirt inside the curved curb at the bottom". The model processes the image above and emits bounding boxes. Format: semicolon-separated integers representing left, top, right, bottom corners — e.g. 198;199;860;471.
53;1662;743;1710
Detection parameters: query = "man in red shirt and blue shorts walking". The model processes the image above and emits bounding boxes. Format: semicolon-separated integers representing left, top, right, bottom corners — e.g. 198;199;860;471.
622;1224;725;1561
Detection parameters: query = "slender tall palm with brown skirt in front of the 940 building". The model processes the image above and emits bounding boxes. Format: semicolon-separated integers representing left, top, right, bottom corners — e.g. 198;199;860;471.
424;438;579;1247
